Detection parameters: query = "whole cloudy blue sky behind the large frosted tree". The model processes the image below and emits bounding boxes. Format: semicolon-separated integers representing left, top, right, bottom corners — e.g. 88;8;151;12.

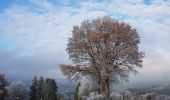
0;0;170;82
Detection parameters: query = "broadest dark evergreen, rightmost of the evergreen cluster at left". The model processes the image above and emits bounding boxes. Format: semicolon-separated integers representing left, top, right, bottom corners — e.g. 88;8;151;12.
44;78;57;100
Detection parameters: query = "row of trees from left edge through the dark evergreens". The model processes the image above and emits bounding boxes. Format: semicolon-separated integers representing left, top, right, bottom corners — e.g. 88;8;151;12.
0;73;62;100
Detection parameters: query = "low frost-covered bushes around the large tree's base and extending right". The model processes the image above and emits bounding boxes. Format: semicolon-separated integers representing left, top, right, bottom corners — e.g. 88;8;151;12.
76;77;170;100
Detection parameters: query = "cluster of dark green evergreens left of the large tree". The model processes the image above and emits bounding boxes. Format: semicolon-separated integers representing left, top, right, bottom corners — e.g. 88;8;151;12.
30;76;57;100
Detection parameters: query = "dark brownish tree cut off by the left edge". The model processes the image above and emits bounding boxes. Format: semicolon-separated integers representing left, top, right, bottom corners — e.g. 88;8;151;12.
0;73;7;100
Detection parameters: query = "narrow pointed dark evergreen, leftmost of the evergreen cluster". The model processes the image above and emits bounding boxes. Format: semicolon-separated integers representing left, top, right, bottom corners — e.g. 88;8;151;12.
30;76;38;100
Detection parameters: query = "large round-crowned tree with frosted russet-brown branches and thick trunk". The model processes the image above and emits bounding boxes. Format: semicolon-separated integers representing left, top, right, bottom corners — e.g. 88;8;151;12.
60;16;144;97
